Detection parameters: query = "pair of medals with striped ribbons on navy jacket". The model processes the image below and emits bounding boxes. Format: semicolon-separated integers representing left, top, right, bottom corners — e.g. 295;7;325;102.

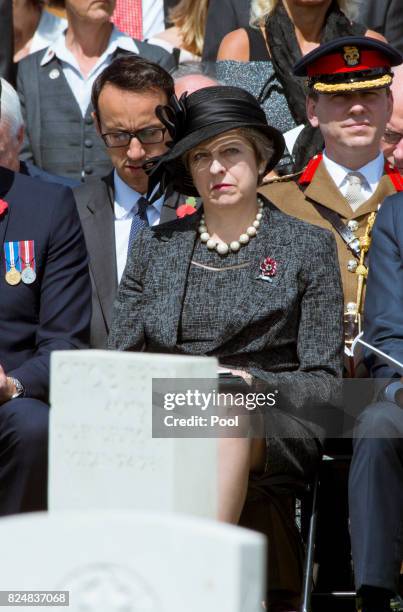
4;240;36;285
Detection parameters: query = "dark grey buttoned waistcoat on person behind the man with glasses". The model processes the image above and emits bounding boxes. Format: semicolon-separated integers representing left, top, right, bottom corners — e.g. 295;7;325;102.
17;40;175;181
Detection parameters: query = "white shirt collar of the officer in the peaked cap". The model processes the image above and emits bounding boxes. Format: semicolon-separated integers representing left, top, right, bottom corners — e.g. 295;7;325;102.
323;150;385;200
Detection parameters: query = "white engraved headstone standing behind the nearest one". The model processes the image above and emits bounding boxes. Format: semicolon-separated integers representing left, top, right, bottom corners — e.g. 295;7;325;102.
49;351;217;517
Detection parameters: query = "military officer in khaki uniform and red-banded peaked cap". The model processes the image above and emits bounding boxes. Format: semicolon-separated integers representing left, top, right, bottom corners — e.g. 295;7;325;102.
261;37;403;350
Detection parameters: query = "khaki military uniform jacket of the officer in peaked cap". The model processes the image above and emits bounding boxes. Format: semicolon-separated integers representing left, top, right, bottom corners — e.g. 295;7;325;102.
259;161;396;312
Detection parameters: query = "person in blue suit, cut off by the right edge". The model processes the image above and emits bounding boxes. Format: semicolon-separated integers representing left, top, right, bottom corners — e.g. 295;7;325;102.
349;193;403;612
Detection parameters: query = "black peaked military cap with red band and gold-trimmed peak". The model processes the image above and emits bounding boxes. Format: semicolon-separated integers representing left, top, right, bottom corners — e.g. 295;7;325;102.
294;36;403;94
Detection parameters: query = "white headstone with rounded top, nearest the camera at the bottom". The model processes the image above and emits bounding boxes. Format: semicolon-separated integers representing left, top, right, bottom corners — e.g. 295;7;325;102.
0;511;265;612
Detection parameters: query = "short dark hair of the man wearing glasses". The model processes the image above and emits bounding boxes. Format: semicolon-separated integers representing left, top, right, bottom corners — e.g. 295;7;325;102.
91;55;174;116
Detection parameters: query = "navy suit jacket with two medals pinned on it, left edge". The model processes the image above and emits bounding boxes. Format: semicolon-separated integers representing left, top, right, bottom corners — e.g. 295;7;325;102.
0;168;91;401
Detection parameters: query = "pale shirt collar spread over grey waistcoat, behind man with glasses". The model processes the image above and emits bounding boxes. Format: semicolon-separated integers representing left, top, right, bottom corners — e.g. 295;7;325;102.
40;26;139;67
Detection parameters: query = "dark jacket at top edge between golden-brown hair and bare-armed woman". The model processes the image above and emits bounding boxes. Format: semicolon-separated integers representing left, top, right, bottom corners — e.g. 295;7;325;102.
203;0;251;62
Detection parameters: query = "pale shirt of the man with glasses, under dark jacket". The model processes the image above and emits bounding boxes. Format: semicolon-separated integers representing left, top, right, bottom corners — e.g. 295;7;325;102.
113;170;164;283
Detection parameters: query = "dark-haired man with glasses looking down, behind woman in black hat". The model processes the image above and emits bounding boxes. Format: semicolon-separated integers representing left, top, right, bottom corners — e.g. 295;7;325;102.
74;55;193;348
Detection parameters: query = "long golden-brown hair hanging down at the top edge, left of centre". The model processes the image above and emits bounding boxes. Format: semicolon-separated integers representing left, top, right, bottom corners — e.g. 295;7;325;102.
169;0;209;56
